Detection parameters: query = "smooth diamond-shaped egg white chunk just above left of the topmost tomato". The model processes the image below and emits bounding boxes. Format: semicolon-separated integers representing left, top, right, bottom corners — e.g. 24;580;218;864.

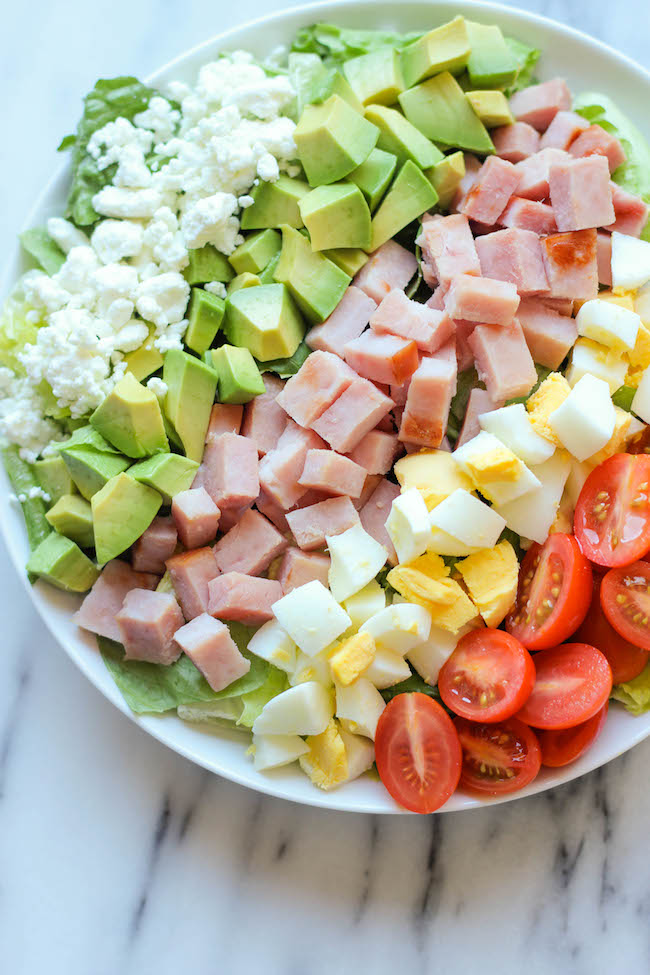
549;375;616;460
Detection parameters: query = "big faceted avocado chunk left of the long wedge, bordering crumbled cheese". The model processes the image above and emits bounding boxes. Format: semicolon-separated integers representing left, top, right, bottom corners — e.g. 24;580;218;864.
90;373;169;457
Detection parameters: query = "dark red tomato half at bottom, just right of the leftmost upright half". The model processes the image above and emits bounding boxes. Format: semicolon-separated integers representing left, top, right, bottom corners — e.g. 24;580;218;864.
454;718;542;796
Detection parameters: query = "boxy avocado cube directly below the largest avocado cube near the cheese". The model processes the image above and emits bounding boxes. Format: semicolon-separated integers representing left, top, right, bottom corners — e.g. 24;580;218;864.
300;183;370;251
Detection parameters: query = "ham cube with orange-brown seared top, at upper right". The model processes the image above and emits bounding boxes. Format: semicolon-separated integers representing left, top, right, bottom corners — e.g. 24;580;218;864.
541;229;598;301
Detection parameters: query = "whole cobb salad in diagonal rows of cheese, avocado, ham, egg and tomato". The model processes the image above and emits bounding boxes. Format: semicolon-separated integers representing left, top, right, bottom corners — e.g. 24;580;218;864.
0;17;650;812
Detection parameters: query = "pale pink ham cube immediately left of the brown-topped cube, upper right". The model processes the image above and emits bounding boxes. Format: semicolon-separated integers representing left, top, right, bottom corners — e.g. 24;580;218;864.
476;227;548;297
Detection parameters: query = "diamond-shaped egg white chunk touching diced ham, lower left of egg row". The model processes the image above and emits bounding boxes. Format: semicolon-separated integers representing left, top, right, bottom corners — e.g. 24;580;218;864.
272;579;350;657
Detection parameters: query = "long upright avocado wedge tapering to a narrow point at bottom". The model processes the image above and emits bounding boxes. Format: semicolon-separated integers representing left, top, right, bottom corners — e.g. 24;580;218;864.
163;349;217;461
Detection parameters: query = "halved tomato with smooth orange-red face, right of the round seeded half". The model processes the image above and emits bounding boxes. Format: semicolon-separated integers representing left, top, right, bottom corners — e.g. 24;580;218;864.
517;643;612;729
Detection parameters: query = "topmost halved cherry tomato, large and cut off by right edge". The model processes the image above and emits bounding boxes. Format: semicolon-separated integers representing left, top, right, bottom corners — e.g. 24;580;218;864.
574;454;650;567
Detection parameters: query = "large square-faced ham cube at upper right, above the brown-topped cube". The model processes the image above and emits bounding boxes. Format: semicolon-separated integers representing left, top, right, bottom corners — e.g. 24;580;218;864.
548;156;615;232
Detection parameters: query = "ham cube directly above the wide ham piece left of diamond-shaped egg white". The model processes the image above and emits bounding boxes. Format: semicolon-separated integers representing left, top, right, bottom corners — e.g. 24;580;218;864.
213;508;288;576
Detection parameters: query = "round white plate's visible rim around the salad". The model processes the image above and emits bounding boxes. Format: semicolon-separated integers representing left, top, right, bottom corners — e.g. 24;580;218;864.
0;0;650;813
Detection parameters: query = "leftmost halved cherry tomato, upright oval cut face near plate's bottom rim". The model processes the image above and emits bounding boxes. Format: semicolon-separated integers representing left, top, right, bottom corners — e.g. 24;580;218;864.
375;692;463;813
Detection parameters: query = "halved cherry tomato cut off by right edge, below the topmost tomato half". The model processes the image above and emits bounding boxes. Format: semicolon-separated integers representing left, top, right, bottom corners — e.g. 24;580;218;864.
600;562;650;652
